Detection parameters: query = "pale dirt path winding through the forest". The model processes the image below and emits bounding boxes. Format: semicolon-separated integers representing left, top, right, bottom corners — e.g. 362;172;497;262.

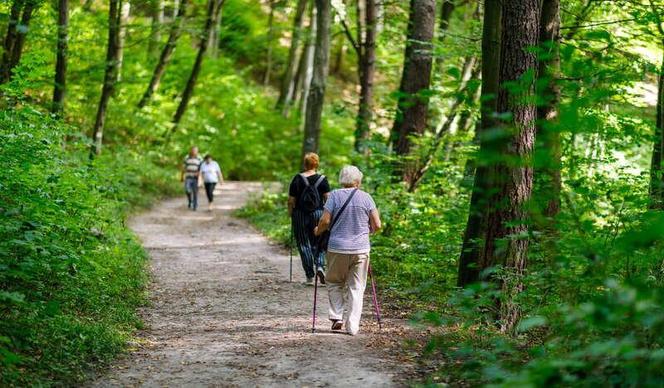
92;182;416;387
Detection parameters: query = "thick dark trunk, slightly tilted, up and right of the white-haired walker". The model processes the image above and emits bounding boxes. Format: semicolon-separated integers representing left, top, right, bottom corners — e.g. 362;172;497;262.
391;0;436;158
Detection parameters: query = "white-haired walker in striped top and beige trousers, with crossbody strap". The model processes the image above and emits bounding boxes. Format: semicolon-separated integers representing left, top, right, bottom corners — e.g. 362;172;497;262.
314;166;382;335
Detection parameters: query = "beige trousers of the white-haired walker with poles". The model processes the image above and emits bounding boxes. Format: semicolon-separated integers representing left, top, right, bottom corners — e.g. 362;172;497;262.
325;252;369;335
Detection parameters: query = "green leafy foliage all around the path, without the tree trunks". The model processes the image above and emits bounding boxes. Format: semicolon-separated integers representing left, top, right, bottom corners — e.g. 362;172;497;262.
0;0;664;386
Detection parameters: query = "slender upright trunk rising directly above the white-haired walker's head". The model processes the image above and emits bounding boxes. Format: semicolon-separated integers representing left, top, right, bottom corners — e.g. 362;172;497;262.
355;0;378;153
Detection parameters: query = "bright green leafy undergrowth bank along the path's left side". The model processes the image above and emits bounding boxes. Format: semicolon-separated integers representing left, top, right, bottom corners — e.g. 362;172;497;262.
0;106;178;385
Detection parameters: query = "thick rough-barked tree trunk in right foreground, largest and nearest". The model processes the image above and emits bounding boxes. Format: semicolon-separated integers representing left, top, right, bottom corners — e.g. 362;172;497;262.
480;0;541;332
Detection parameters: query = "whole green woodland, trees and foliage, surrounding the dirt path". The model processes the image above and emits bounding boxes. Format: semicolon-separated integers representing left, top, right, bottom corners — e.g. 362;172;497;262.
0;0;664;386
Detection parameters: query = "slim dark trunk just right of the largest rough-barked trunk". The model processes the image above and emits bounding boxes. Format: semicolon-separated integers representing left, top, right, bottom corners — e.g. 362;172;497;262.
535;0;562;218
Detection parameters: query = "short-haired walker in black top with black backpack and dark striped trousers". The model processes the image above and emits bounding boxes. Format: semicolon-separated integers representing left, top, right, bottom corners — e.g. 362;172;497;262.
288;152;330;285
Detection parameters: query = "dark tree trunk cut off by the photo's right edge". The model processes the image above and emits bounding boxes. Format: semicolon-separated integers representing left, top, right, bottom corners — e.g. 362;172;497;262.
650;53;664;210
